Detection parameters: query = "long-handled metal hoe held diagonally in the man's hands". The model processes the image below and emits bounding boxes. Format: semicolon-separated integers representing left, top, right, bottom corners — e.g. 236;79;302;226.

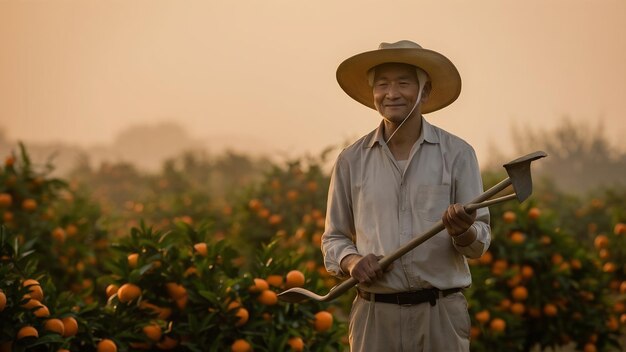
278;151;547;303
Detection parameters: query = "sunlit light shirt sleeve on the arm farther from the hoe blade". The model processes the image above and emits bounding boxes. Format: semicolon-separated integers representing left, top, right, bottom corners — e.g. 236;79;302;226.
322;153;358;278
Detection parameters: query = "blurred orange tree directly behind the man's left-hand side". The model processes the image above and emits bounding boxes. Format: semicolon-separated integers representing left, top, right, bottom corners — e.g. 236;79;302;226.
231;154;354;312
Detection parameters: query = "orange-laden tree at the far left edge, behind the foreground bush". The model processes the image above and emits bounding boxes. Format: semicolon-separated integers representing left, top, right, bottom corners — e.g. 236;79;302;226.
0;145;107;297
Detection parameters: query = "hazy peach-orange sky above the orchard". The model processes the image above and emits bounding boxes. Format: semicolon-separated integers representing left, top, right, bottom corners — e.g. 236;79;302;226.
0;0;626;165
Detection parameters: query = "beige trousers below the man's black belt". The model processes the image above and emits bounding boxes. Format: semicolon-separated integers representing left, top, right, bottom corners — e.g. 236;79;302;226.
349;292;471;352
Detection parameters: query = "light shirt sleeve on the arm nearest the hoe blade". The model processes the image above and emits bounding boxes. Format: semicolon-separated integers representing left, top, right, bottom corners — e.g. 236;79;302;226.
452;148;491;258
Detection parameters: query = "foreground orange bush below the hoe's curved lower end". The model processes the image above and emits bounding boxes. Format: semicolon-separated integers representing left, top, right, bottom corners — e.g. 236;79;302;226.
96;223;345;351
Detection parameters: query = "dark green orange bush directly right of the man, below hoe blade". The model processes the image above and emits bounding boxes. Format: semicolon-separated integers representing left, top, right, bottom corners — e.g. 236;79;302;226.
468;180;623;351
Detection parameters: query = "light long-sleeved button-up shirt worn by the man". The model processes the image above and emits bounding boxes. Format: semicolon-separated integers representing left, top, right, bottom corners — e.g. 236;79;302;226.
322;119;491;293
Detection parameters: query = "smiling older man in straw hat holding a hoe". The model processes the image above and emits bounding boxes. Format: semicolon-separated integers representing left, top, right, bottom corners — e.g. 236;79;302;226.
322;40;490;352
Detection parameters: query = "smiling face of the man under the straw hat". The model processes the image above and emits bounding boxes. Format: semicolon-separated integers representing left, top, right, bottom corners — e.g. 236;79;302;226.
372;63;419;123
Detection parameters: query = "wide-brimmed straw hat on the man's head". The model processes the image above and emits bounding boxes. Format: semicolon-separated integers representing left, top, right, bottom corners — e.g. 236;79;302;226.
337;40;461;114
